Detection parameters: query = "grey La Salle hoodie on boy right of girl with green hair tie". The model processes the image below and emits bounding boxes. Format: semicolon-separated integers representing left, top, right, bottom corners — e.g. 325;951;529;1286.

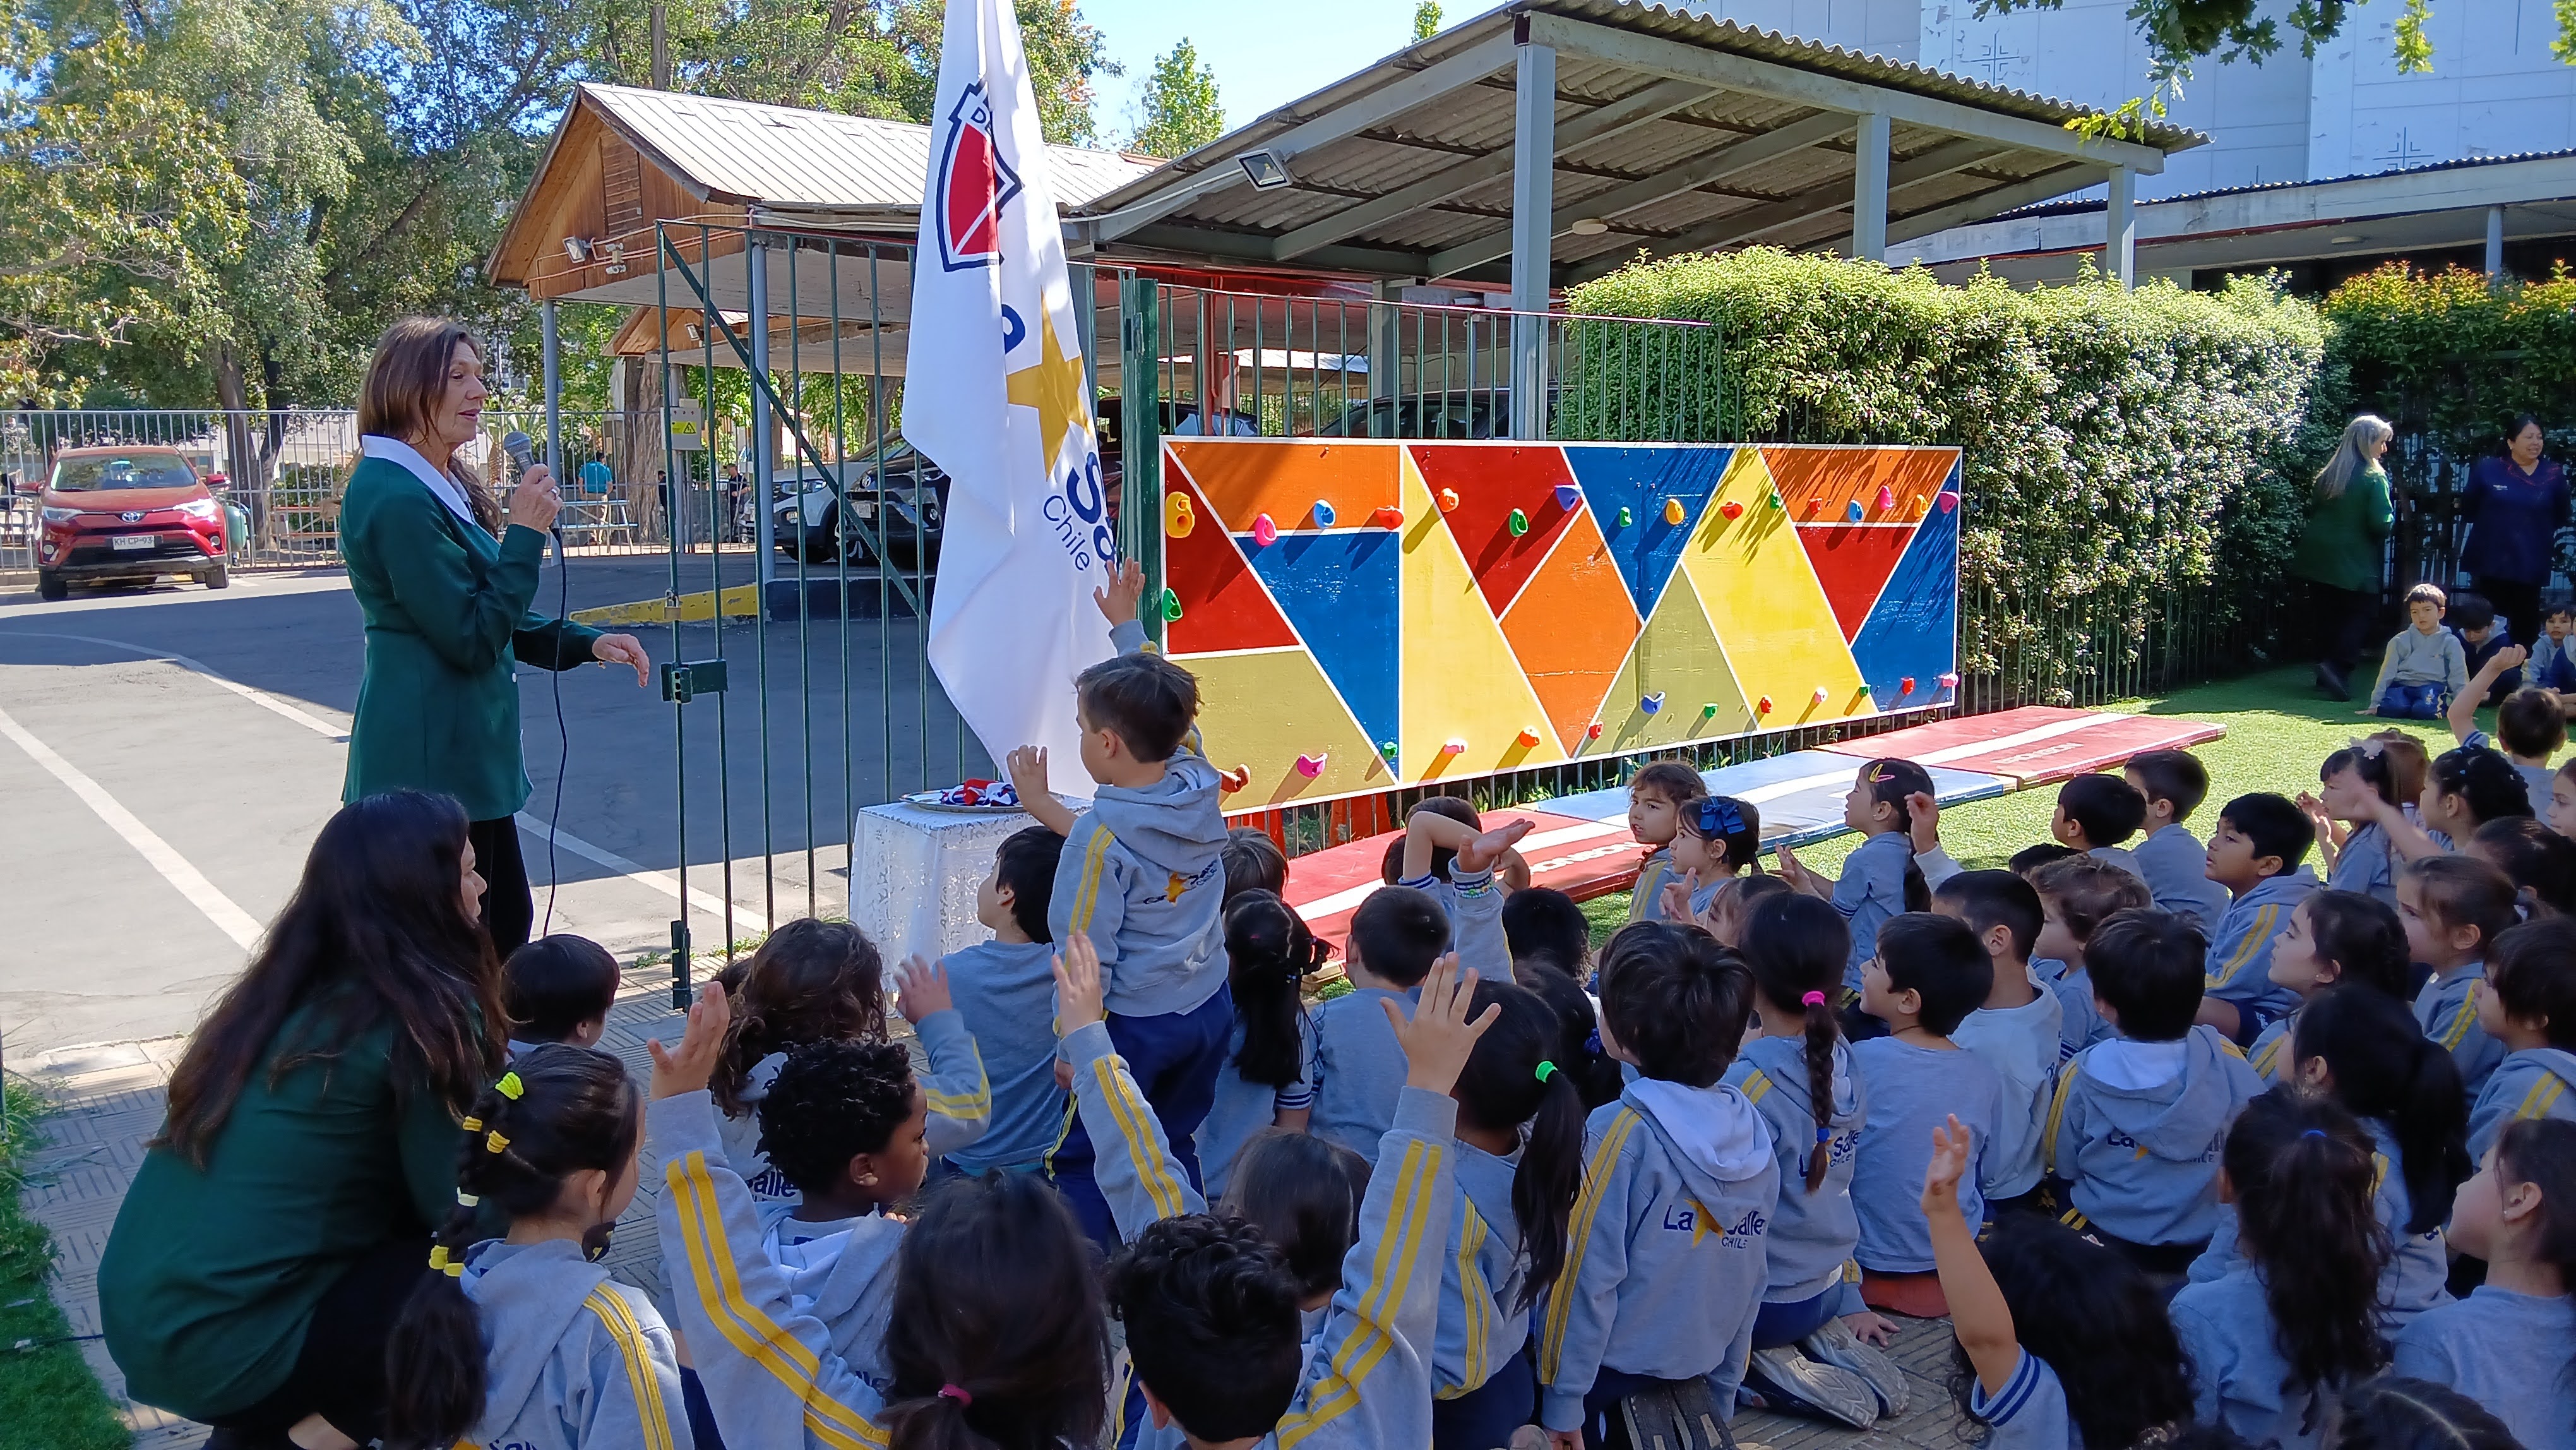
1538;1079;1780;1429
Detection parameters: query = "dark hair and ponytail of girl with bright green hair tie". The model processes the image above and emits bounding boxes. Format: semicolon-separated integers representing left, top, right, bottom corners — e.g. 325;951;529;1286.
1453;981;1584;1309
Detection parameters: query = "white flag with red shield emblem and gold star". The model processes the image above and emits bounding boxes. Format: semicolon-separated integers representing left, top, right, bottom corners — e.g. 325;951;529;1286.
904;0;1112;793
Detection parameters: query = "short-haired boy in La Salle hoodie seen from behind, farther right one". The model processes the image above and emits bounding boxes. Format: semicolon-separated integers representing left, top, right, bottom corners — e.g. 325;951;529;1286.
2048;911;2264;1275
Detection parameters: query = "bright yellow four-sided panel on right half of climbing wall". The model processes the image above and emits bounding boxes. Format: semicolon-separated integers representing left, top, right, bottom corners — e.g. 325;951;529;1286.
1667;448;1878;729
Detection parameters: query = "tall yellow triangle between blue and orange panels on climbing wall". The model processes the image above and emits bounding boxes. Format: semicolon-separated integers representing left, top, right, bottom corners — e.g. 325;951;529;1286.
1402;448;1576;781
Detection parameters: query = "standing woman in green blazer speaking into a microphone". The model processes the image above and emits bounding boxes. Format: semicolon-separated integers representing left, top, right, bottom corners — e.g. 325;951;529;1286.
340;317;649;961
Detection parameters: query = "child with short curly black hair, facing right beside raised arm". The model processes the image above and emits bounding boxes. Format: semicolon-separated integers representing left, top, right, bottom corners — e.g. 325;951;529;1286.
760;1038;930;1393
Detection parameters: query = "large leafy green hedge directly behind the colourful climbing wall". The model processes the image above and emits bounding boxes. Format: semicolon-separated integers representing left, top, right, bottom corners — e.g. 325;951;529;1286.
1561;248;2342;703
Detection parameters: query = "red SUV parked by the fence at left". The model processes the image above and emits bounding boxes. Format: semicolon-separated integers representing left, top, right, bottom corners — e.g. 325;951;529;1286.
36;448;232;600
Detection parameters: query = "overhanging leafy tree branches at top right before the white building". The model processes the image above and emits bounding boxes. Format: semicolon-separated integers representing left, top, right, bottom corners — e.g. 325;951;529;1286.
1976;0;2576;136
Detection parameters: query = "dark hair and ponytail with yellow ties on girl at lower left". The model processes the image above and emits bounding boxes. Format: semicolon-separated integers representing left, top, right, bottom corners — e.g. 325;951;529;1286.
384;1043;644;1450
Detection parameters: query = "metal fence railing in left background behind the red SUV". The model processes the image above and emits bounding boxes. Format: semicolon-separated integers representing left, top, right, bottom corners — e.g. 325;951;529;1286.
0;407;747;572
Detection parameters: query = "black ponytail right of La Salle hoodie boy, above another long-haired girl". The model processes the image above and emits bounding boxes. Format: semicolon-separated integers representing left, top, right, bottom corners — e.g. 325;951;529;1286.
2290;984;2476;1233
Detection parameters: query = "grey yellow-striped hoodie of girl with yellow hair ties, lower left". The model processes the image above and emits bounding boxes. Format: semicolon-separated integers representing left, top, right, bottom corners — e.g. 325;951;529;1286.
458;1239;693;1450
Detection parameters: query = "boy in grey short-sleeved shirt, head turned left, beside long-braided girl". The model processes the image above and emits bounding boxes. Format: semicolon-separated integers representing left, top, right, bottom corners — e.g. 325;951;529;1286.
1852;911;1999;1316
